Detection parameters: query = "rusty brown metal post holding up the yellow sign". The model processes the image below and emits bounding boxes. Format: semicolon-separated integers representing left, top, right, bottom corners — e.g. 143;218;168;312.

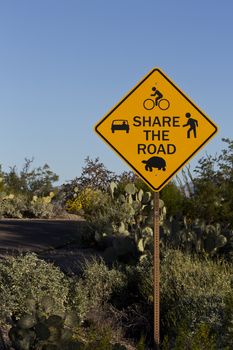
154;192;160;350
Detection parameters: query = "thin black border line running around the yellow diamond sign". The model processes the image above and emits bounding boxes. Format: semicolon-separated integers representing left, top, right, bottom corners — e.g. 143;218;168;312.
95;68;218;192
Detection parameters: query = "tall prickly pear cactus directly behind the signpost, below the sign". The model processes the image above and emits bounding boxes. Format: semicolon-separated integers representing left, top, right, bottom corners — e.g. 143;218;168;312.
101;183;165;258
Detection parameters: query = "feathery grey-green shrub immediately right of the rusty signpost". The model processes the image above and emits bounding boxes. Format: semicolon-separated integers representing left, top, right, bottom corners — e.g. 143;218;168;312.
161;250;232;342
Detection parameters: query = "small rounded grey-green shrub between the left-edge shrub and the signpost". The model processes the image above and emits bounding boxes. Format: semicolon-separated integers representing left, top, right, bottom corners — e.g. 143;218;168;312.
70;259;126;317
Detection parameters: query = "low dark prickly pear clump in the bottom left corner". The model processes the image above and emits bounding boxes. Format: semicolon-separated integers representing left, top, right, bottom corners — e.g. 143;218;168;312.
9;298;82;350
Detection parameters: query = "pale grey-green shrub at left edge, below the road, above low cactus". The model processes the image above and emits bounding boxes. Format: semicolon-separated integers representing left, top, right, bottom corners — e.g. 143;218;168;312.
0;253;69;319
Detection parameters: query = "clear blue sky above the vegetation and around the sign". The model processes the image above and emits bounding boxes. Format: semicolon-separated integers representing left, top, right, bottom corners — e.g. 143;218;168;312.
0;0;233;182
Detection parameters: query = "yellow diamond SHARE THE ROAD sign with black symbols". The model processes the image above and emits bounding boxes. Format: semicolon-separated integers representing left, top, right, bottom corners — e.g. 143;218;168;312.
95;68;217;191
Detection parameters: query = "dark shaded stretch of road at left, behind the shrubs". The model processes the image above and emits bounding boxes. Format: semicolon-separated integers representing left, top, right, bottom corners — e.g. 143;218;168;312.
0;219;97;274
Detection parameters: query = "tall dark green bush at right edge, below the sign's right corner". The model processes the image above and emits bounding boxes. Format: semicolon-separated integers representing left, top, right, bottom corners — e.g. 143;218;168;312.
177;139;233;229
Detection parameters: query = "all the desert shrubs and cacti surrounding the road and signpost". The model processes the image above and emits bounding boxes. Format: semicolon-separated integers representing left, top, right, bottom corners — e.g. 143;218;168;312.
0;139;233;350
